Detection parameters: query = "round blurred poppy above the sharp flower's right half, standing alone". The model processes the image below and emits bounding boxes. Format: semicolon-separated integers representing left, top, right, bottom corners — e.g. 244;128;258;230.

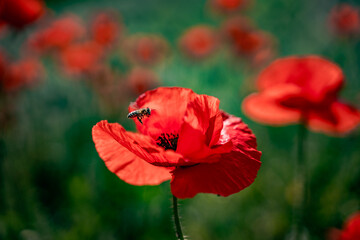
179;25;218;59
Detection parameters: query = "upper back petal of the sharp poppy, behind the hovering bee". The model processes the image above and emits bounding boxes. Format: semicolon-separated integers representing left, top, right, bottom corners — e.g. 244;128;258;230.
129;87;196;140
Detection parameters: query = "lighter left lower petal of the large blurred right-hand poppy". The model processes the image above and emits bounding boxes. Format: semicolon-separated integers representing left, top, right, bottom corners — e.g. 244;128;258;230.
242;84;301;125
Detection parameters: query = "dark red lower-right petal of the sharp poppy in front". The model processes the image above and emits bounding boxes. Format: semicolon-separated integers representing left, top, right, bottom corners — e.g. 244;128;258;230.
171;114;261;198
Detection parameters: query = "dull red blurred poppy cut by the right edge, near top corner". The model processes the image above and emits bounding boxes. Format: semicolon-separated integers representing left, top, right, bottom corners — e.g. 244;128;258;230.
329;3;360;36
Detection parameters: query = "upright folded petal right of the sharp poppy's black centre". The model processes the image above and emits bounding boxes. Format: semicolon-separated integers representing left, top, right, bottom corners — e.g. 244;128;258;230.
177;95;232;162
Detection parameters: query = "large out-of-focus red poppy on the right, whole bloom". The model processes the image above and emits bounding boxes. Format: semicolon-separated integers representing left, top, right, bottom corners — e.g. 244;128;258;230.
242;56;360;134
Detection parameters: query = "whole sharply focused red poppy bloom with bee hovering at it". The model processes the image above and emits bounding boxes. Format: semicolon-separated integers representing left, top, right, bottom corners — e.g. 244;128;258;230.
92;87;261;198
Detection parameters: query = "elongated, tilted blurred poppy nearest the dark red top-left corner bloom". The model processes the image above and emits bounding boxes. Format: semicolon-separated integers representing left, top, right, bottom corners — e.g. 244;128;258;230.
27;15;86;52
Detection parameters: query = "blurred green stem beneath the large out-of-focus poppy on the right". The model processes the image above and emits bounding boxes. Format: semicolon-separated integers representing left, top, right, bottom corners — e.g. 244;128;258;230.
292;124;307;240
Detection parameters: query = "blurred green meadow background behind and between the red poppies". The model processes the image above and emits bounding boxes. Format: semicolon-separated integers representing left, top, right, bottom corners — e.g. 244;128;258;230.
0;0;360;240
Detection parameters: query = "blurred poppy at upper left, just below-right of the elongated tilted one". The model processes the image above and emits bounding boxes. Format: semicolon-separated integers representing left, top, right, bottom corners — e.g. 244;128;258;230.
60;42;103;75
